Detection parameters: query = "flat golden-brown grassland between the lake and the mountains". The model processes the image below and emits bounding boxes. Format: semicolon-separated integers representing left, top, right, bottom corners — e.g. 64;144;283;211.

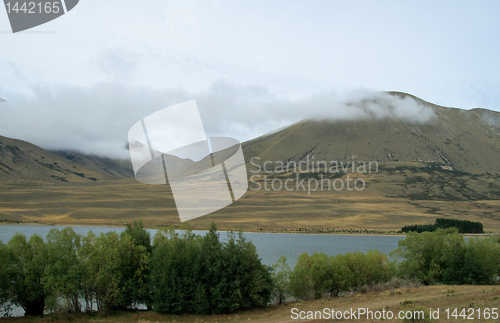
0;173;500;233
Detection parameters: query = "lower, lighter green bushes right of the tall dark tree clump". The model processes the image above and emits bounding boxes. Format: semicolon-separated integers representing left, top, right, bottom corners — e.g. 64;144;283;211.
273;228;500;303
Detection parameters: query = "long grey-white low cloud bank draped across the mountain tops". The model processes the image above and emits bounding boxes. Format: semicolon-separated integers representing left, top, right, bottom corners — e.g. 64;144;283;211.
0;81;434;158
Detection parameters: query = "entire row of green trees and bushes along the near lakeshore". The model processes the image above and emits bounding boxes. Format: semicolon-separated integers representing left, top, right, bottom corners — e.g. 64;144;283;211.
0;221;500;315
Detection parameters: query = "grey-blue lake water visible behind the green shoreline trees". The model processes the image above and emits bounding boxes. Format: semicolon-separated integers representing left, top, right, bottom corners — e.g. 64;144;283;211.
0;225;404;268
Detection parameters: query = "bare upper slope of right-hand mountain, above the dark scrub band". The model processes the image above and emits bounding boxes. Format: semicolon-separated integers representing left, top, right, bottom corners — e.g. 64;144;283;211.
243;92;500;174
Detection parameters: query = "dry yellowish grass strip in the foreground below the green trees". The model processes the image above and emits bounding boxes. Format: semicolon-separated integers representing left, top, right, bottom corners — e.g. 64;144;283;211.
0;285;500;323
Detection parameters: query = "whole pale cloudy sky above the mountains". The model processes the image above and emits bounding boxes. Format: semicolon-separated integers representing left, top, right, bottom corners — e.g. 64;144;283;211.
0;0;500;158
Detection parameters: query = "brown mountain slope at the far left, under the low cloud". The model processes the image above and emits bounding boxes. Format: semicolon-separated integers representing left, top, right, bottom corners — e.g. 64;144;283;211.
0;136;128;184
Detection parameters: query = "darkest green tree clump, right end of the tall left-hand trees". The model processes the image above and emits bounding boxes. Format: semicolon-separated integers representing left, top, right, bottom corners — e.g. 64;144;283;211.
151;223;273;314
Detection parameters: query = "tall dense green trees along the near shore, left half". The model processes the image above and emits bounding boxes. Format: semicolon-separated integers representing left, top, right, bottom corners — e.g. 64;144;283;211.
0;221;273;315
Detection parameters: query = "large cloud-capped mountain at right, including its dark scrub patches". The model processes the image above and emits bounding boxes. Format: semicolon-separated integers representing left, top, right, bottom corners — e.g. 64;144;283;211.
243;92;500;202
